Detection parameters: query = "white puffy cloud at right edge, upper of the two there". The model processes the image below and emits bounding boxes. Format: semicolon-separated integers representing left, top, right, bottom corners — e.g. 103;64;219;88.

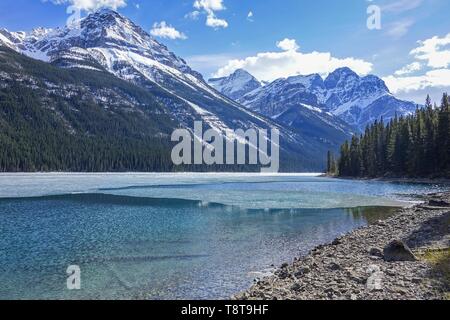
411;33;450;69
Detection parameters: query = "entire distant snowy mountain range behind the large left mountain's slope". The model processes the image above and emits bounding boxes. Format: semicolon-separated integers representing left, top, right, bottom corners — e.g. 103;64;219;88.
209;68;417;131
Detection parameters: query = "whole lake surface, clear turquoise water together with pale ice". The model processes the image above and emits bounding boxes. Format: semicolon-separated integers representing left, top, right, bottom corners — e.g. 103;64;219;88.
0;174;445;299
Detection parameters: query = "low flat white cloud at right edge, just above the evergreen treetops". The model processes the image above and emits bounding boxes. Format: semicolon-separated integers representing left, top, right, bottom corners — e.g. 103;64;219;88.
383;69;450;94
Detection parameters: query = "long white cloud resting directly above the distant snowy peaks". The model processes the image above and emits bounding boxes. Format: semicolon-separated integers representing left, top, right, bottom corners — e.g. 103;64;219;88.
214;39;372;81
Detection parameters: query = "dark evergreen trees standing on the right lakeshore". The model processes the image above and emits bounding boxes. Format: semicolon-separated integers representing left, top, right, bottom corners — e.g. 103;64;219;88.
328;93;450;178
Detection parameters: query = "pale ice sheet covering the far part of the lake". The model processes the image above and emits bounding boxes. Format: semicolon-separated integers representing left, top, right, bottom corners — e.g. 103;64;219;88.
0;173;443;209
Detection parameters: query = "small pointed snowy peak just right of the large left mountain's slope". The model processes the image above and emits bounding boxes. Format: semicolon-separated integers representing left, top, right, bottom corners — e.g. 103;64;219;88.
208;69;262;100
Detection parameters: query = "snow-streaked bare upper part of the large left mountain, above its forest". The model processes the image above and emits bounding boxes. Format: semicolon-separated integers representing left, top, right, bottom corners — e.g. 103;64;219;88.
0;10;349;170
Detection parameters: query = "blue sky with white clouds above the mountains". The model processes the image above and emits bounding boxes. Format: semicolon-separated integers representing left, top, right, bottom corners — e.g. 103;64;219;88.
0;0;450;103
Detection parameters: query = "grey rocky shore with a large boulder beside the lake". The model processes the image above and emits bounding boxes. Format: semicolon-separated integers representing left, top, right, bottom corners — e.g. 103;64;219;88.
234;193;450;300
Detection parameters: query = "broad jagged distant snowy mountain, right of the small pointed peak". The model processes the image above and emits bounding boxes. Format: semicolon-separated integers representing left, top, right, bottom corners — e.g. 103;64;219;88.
218;68;417;130
